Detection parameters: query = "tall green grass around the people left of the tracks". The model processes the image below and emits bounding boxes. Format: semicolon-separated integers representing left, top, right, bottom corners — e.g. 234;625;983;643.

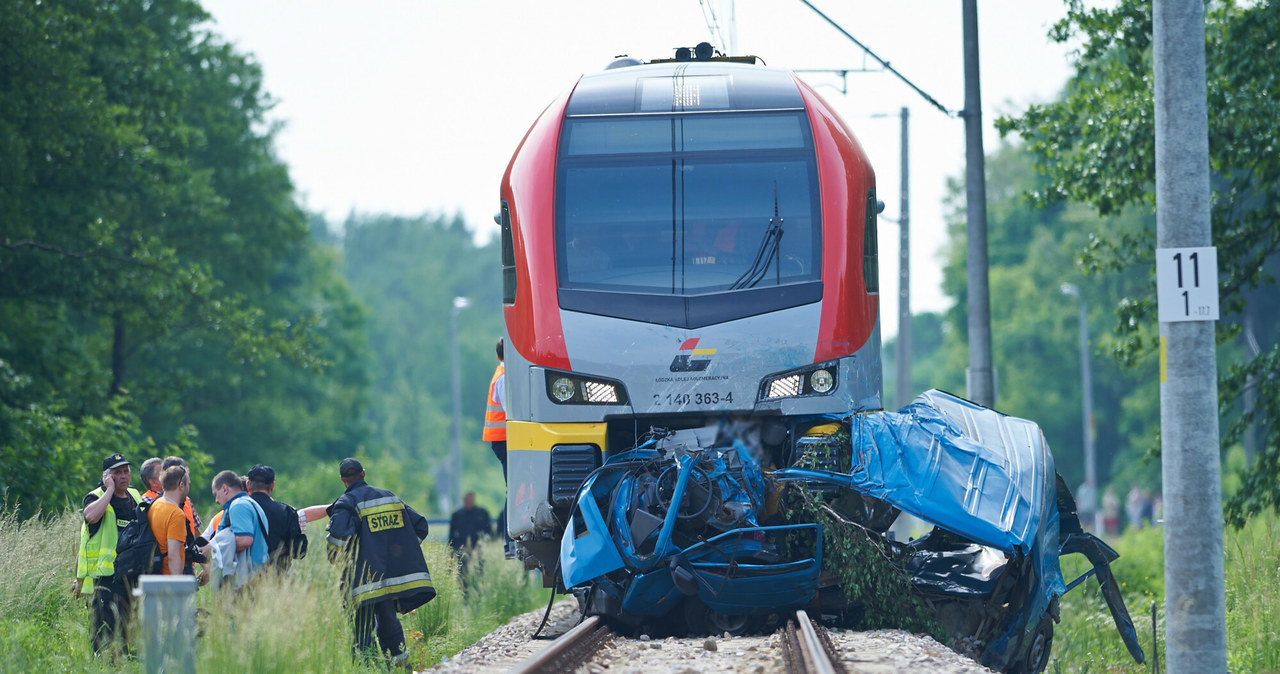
0;510;549;673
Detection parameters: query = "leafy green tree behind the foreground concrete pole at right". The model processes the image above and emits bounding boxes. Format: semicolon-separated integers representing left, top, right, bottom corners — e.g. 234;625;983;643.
997;0;1280;526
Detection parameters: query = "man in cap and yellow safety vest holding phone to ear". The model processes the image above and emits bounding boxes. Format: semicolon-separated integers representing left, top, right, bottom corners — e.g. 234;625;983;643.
76;454;142;654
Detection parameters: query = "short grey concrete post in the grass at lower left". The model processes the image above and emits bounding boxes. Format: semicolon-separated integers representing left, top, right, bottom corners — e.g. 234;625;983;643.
133;576;197;674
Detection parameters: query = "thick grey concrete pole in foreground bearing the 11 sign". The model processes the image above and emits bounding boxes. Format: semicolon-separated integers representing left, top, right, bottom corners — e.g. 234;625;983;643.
1152;0;1226;674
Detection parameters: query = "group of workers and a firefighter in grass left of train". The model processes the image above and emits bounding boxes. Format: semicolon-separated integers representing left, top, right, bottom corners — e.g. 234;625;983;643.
73;454;435;665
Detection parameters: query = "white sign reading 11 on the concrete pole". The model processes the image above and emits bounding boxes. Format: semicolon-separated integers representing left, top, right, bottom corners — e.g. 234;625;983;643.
1156;247;1219;324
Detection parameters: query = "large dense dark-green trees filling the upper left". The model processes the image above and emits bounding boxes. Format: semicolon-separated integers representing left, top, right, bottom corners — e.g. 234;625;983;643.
0;0;367;505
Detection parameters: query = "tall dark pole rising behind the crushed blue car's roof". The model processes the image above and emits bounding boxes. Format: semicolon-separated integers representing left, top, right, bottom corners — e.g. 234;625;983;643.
964;0;996;407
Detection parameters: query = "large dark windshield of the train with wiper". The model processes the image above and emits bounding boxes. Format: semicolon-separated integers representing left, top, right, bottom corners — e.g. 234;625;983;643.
556;110;822;295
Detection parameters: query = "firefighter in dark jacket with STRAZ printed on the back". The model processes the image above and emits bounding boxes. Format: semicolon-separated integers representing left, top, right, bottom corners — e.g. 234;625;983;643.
328;459;435;665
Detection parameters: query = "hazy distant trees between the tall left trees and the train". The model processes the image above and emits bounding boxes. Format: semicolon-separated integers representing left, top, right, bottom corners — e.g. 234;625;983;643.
342;215;506;515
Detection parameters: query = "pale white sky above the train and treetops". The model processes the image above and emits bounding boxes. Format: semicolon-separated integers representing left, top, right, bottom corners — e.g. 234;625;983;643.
202;0;1070;336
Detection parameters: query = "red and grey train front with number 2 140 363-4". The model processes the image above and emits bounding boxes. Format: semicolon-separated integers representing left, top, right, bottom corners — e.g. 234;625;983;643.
500;59;881;583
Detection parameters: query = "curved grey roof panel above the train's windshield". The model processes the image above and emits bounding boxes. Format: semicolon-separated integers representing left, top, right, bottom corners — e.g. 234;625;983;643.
566;59;804;116
